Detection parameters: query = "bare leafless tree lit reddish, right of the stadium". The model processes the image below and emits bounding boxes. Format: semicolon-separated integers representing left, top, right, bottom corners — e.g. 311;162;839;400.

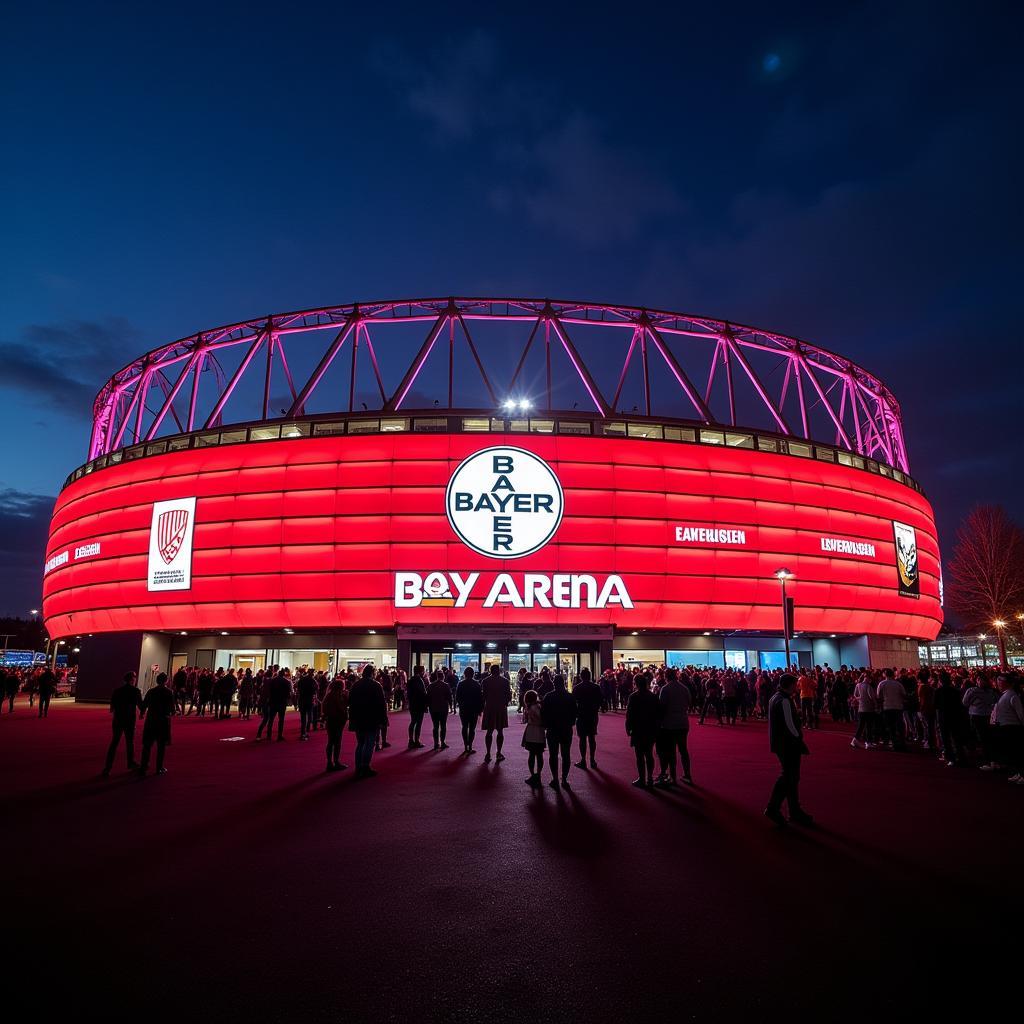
949;505;1024;668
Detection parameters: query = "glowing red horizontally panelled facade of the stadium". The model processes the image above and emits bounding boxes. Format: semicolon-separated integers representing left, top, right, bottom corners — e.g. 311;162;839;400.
43;296;942;696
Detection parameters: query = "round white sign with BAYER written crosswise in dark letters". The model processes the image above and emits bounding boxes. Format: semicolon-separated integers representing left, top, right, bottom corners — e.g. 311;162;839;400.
444;445;564;558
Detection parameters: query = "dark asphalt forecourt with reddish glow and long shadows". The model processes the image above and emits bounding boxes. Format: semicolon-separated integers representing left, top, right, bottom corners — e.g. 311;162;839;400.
0;697;1024;1024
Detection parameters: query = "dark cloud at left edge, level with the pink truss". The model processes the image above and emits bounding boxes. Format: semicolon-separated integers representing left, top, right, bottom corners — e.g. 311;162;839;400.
0;317;141;418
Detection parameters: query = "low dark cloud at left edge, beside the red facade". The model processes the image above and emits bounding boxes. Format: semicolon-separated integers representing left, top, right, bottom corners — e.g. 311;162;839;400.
0;485;54;616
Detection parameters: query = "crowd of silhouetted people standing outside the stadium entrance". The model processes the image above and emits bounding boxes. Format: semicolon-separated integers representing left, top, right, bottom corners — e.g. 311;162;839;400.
0;664;1024;823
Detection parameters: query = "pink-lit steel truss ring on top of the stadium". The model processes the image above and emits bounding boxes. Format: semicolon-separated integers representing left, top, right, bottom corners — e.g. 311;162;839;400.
83;298;909;472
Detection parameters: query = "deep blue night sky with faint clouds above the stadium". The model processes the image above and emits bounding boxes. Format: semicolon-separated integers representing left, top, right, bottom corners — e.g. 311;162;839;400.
0;3;1024;614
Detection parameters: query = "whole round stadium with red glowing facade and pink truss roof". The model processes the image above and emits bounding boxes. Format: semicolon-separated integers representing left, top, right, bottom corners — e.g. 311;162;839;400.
43;298;942;699
